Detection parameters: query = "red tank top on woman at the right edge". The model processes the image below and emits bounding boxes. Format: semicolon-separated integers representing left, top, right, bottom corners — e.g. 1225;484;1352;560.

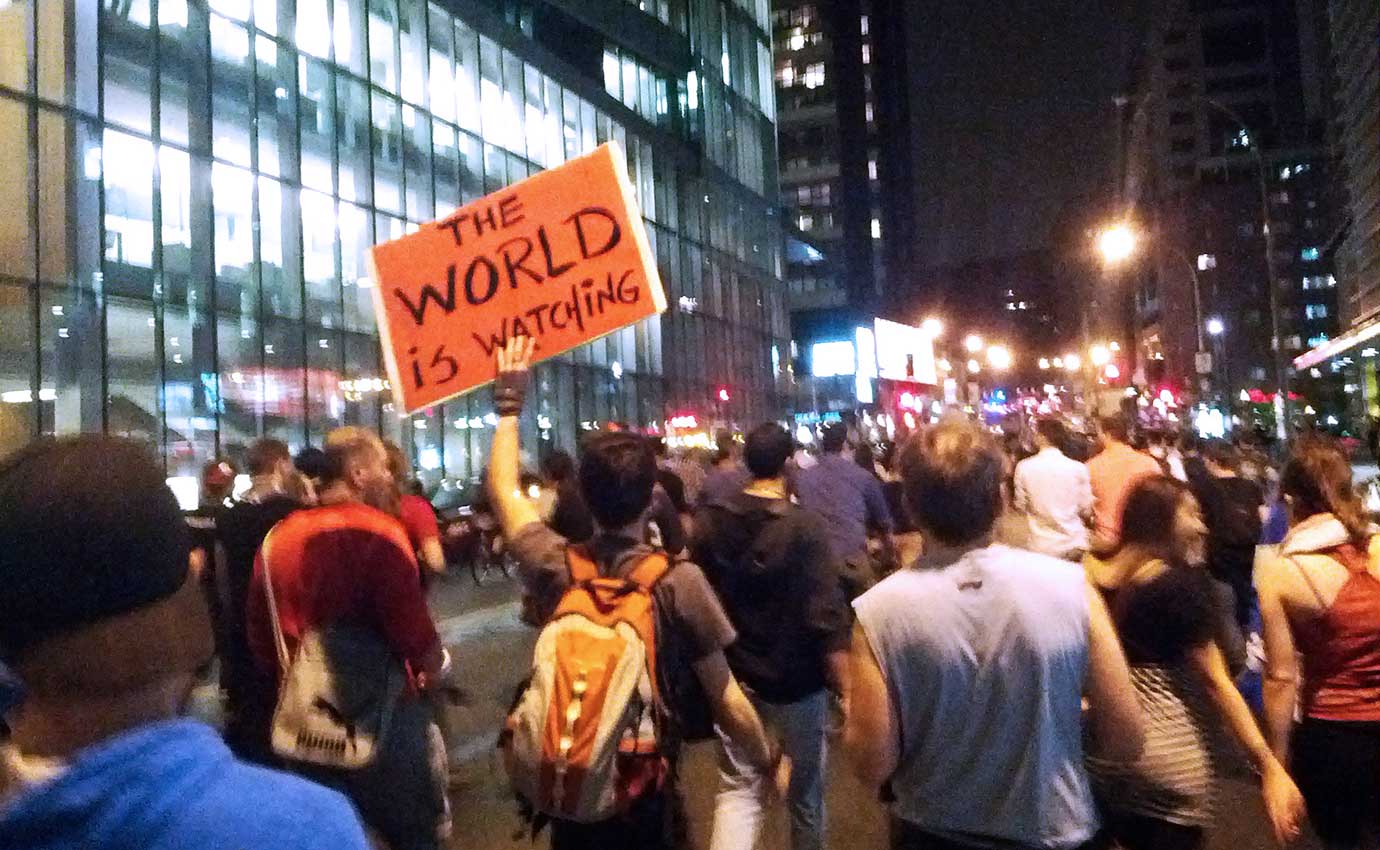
1296;544;1380;720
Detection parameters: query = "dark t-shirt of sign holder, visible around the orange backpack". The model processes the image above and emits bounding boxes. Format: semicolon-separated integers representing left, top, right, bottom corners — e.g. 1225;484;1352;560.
509;523;737;738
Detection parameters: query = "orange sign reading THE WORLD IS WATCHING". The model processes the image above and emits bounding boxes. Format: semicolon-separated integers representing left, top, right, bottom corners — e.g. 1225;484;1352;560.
370;142;667;413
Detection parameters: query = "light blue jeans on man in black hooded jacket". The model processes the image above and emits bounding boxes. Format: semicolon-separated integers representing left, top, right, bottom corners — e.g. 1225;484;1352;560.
709;690;829;850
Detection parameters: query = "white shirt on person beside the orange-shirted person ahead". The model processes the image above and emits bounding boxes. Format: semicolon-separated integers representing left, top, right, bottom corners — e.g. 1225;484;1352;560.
1016;447;1093;557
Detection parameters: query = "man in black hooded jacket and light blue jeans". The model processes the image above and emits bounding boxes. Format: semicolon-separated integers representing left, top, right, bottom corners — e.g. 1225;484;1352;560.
691;424;851;850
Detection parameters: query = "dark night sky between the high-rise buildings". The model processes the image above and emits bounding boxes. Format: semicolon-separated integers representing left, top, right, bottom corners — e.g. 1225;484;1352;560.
909;0;1141;268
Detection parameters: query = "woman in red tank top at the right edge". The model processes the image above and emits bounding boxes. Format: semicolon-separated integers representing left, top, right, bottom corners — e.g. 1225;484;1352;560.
1256;439;1380;849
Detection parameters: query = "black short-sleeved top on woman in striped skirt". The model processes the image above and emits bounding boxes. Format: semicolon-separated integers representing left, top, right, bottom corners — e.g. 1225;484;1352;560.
1104;567;1221;666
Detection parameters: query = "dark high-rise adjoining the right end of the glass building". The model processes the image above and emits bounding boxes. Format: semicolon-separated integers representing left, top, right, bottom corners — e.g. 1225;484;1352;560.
771;0;915;327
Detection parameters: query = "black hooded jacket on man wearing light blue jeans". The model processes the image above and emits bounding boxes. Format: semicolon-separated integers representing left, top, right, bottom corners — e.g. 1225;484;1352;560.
691;493;851;704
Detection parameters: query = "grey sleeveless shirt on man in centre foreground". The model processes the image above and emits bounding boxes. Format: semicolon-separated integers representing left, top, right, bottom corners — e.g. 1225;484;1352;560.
853;545;1097;850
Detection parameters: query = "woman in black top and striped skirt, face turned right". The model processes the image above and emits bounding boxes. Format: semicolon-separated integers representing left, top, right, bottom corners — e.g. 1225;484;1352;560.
1085;476;1303;850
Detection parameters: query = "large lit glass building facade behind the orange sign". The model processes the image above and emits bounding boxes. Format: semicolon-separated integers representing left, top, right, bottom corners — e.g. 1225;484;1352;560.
0;0;789;488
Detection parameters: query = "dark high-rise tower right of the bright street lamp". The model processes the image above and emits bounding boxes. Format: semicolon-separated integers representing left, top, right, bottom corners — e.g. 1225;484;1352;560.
1125;0;1340;422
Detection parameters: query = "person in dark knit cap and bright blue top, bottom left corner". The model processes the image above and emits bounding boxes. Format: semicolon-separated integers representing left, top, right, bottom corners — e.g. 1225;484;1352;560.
0;435;368;850
